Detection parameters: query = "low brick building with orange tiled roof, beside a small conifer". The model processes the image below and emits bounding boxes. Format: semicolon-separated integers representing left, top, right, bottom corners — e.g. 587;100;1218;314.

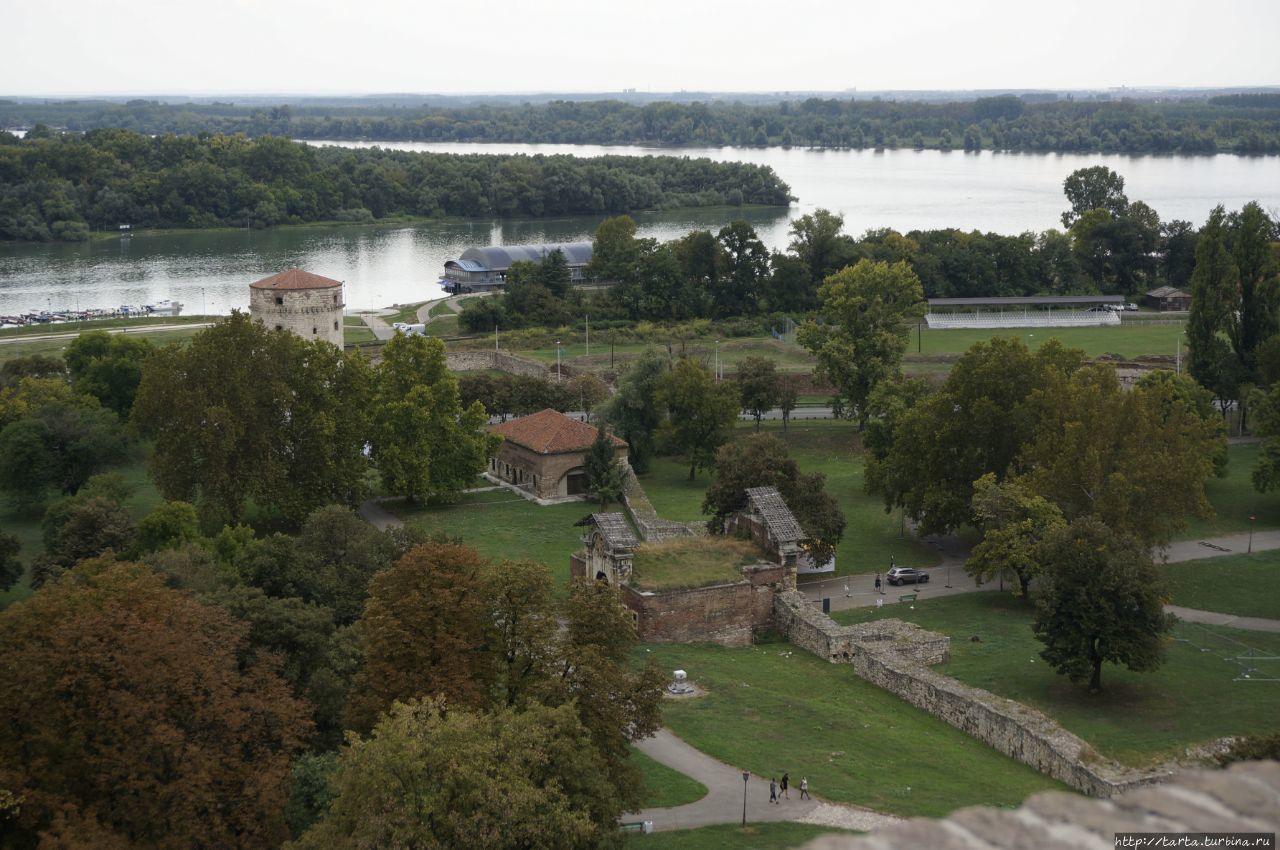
489;408;627;499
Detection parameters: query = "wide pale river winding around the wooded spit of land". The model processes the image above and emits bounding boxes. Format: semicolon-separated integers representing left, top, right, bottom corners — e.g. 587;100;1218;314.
0;142;1280;315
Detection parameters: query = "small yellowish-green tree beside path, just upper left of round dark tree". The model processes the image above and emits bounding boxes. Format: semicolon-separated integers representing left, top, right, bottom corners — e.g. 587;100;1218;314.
964;472;1066;598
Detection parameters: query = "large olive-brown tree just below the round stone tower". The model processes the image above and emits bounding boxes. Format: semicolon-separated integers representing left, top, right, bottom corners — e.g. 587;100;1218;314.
132;312;373;529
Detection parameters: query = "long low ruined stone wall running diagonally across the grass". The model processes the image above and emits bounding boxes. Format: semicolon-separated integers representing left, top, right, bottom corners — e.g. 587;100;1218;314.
774;591;1167;796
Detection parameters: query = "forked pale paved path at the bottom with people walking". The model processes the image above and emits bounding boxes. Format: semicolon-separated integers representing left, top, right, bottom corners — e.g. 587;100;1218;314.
623;730;899;830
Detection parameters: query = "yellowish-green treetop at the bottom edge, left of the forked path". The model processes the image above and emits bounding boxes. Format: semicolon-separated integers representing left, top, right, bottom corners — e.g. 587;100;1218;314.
291;699;622;850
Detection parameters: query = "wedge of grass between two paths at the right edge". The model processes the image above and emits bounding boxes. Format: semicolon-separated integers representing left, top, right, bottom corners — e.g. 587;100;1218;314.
1160;549;1280;620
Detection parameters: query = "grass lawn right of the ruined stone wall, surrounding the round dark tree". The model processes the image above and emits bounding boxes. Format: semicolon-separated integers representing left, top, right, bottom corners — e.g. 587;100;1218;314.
829;593;1280;768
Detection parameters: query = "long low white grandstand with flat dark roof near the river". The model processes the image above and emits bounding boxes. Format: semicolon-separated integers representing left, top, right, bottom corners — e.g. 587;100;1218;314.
924;296;1124;329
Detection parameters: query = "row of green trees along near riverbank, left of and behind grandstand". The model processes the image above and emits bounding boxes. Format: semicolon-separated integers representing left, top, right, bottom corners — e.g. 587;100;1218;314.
460;165;1198;333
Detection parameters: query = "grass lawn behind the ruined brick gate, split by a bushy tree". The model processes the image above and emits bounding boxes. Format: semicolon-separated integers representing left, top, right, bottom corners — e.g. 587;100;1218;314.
640;420;940;575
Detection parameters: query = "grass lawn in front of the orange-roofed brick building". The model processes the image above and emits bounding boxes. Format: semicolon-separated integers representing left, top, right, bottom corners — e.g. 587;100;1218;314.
385;489;588;593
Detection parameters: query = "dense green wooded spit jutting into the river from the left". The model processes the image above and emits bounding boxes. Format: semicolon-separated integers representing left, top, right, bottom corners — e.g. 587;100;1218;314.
0;128;791;241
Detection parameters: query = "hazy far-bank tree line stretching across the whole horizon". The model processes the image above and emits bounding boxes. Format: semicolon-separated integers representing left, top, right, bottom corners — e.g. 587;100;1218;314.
0;93;1280;154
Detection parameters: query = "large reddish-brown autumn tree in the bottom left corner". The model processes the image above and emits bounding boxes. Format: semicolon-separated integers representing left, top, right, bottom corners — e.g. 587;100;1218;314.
0;562;307;850
